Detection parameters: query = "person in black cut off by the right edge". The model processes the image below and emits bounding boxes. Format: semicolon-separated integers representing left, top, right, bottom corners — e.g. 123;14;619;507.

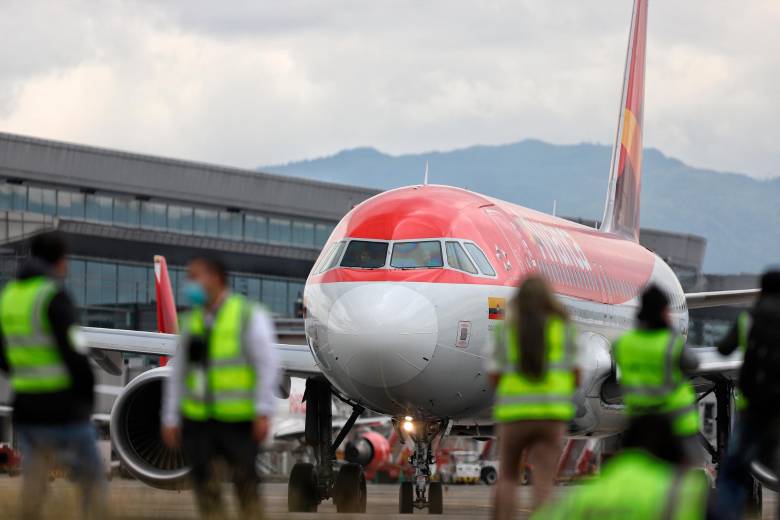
717;271;780;518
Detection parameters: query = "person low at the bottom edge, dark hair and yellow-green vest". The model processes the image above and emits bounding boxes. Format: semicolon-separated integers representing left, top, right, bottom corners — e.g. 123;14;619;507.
531;415;717;520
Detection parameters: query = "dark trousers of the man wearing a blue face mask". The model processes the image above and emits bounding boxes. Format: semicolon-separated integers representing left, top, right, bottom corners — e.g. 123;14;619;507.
182;421;260;519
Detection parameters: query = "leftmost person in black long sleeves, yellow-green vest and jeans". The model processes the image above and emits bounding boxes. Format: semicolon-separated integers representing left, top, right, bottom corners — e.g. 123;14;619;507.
0;233;105;518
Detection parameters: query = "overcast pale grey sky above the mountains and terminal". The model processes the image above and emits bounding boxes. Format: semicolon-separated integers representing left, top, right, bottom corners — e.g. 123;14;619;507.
0;0;780;177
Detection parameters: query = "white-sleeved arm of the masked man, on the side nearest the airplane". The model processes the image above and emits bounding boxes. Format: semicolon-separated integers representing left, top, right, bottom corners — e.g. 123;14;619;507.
245;309;279;419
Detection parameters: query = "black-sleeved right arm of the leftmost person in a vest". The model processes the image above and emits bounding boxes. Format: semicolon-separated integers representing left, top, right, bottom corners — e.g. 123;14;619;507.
48;290;95;405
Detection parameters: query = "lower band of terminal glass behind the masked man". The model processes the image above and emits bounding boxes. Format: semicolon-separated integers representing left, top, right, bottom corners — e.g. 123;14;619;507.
66;257;305;316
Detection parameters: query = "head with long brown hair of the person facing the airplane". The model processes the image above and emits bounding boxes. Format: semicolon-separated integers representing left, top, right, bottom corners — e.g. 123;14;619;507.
509;275;568;378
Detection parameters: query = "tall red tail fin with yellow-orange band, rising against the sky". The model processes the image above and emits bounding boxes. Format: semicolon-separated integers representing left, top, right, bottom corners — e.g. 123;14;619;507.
601;0;648;241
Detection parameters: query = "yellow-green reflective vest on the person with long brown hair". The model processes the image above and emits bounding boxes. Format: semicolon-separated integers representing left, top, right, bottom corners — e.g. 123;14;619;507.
493;317;575;422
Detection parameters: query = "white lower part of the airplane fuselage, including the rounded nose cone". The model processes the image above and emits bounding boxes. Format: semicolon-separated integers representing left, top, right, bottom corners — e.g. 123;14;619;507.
305;254;688;431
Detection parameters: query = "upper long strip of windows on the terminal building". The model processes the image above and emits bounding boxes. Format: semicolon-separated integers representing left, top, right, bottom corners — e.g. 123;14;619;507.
0;181;334;249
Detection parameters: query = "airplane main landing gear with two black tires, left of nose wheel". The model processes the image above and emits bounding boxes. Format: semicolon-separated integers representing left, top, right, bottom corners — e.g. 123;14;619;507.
287;378;367;513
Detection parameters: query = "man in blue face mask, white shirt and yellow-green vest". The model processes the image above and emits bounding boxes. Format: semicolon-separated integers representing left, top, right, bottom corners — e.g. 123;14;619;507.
162;257;278;518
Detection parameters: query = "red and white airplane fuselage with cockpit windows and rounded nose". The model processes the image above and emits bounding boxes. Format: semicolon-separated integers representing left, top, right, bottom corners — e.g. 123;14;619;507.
304;186;688;431
